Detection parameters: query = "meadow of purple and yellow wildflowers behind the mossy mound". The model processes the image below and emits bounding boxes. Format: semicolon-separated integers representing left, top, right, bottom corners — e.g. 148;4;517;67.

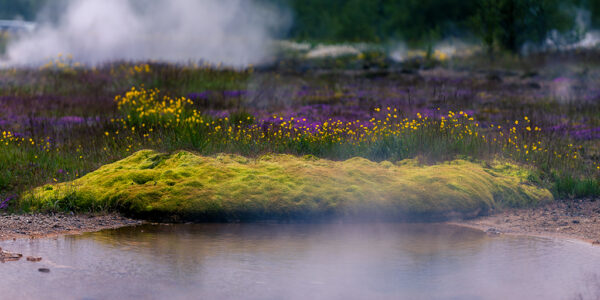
0;52;600;216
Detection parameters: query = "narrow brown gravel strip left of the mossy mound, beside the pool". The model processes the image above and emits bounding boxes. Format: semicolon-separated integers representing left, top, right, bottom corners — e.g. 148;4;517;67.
0;214;142;240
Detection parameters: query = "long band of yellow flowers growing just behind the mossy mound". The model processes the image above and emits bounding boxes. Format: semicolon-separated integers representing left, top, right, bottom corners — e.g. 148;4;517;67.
111;88;592;171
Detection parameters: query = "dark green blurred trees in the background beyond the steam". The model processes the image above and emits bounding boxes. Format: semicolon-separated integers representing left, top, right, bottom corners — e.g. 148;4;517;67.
0;0;600;52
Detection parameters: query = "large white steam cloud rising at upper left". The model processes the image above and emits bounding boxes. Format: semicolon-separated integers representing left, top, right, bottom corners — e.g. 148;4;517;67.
2;0;289;67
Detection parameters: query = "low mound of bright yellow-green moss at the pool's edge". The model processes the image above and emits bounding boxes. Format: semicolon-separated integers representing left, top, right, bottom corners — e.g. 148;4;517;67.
24;150;552;221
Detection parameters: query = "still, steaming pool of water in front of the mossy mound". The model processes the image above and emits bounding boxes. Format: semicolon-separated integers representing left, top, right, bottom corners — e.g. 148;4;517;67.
0;224;600;299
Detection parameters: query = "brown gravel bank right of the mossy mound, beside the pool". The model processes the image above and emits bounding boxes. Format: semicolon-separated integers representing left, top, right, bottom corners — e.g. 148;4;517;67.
449;198;600;245
